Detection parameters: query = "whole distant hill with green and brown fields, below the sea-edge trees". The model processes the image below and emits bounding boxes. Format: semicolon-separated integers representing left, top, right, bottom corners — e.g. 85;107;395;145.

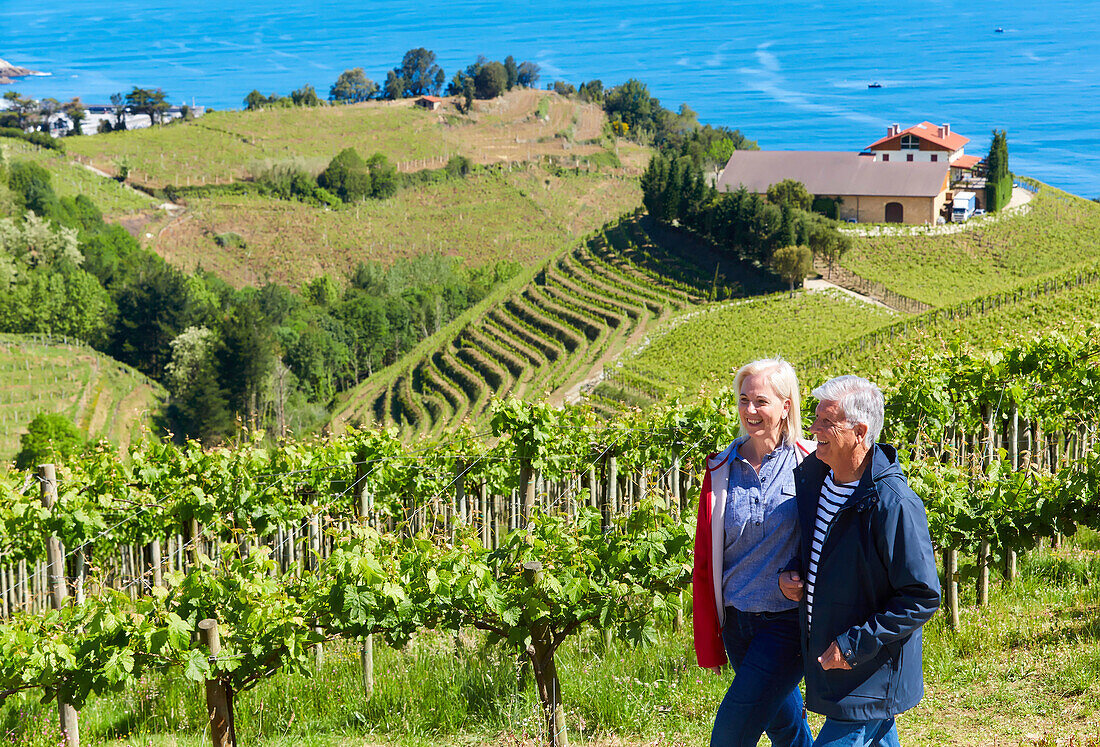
55;89;649;287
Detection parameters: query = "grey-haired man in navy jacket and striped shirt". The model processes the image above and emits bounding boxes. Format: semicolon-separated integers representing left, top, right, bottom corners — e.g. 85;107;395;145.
779;376;939;747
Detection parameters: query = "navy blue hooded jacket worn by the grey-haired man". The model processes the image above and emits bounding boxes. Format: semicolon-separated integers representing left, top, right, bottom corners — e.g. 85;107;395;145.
789;443;939;721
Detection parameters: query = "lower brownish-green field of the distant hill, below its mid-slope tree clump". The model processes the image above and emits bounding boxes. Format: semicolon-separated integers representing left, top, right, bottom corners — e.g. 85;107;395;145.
145;164;641;286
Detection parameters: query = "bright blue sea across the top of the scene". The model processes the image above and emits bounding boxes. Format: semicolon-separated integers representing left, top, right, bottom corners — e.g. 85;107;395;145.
0;0;1100;197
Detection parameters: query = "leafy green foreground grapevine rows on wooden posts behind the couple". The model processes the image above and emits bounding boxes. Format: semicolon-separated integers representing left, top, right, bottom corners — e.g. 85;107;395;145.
0;329;1100;745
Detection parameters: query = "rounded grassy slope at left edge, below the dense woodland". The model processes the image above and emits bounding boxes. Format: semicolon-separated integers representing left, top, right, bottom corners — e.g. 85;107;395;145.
0;334;165;460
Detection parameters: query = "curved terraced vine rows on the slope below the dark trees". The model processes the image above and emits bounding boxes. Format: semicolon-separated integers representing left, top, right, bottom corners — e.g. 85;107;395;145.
339;216;774;436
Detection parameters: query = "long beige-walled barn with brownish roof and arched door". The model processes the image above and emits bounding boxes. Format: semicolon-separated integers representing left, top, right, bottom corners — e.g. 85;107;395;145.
717;151;950;224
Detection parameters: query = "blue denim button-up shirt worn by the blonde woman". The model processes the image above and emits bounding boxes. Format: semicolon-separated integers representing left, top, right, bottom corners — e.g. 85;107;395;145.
722;436;799;612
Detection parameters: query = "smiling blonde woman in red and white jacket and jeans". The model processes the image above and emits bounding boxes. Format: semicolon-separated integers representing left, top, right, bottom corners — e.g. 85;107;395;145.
692;358;813;747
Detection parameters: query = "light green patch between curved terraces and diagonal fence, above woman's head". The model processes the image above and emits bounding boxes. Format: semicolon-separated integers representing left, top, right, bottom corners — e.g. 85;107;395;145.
609;292;898;396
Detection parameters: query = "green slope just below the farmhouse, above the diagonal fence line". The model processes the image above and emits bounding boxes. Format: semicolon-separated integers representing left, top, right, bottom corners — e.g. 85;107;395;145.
842;186;1100;306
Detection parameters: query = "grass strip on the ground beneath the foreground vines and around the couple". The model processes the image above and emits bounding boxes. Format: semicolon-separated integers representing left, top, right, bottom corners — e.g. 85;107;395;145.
0;530;1100;747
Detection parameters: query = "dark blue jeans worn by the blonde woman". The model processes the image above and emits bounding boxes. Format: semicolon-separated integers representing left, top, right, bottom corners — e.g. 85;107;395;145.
711;607;813;747
